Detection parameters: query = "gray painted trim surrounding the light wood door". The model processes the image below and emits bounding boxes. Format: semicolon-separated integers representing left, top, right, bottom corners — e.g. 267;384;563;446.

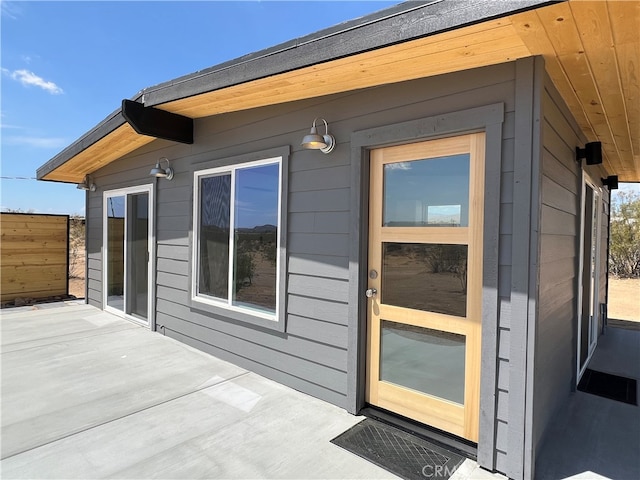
345;102;505;468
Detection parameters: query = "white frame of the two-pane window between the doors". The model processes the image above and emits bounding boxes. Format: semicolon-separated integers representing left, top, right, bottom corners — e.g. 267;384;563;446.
191;156;285;322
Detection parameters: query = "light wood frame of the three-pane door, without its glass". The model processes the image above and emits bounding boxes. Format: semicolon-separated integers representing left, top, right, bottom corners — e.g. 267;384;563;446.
366;132;486;442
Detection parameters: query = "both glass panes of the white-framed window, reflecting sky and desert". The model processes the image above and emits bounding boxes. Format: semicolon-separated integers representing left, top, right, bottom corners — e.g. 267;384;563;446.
198;163;280;313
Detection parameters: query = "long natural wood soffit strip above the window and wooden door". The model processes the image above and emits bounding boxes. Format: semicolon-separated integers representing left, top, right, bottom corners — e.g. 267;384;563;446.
162;19;530;118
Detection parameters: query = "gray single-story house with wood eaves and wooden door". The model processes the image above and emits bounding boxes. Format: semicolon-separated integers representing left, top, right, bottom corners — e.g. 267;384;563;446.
38;1;640;479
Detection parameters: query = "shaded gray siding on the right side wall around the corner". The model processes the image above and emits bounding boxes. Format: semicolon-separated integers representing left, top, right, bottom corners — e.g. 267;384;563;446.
532;70;608;476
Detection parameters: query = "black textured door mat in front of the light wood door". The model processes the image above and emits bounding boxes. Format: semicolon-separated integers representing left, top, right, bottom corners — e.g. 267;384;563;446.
331;418;464;480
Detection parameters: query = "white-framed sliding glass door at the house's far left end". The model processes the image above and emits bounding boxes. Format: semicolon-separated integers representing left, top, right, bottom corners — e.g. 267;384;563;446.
104;187;151;324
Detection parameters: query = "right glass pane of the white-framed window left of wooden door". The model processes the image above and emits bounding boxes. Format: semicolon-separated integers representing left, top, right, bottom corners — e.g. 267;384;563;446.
233;164;280;313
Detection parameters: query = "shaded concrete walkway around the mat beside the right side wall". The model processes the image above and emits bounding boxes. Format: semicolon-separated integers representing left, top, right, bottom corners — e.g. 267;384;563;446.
536;322;640;480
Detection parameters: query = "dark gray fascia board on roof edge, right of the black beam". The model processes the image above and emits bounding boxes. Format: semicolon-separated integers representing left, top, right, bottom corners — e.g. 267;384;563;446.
144;0;557;106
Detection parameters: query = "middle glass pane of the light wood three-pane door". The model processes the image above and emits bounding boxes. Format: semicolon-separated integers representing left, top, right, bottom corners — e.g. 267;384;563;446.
381;242;468;317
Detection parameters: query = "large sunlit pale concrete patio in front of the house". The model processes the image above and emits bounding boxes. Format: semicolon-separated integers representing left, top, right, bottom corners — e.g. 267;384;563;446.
0;302;502;480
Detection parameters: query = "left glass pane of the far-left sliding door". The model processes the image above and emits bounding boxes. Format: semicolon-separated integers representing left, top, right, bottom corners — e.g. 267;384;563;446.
106;196;125;311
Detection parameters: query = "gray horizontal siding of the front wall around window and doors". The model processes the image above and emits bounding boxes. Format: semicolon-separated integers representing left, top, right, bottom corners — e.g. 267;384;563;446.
87;59;534;478
